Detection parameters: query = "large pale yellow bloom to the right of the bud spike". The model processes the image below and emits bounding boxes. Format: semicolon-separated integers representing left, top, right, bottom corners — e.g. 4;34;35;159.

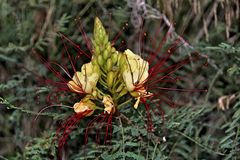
122;49;149;92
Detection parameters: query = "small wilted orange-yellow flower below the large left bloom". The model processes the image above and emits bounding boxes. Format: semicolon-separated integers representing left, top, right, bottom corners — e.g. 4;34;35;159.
73;99;95;116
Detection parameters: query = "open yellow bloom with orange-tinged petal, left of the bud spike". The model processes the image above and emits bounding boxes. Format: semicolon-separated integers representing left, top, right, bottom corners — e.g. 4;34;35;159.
67;62;99;93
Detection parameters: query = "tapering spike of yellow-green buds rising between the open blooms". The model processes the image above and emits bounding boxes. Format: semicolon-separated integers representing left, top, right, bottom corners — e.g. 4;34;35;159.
89;18;127;107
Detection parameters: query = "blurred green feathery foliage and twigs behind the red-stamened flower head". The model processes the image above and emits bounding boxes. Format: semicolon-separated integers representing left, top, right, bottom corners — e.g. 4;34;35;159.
0;0;240;160
